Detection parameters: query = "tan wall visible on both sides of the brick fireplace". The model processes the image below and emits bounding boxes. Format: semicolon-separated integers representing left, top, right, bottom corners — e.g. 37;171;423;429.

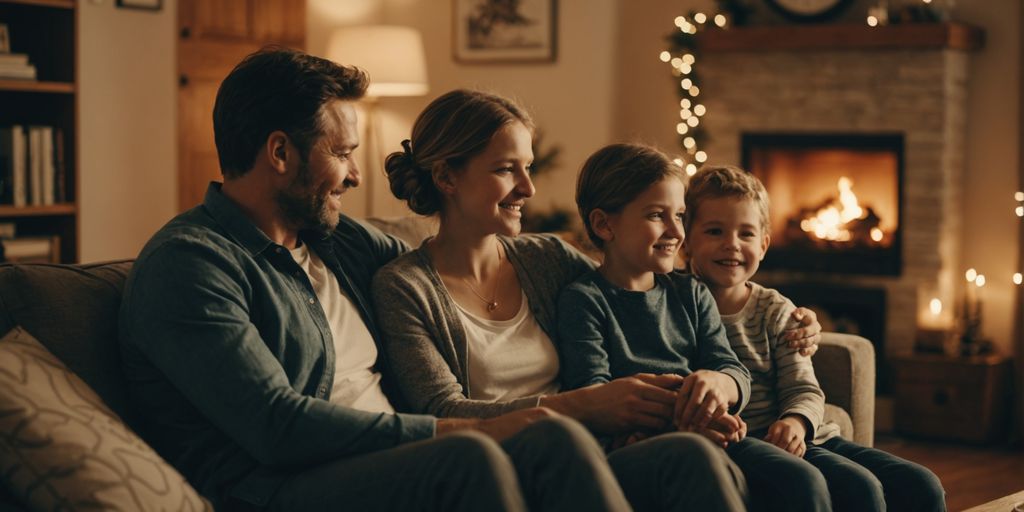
613;0;1022;352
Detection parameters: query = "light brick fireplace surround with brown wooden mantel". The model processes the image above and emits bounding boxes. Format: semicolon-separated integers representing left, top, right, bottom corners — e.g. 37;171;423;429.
695;24;982;391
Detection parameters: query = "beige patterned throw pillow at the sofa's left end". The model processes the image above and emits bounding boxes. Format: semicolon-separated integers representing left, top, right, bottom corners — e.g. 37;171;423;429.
0;327;211;511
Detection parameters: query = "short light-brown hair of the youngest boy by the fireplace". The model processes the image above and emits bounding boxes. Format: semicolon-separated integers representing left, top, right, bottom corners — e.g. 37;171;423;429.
683;165;769;232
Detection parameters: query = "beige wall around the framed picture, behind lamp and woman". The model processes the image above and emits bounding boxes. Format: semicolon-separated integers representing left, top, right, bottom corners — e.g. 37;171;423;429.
307;0;618;216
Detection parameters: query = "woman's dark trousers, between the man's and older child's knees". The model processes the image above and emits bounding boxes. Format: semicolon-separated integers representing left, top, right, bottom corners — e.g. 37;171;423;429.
608;432;748;511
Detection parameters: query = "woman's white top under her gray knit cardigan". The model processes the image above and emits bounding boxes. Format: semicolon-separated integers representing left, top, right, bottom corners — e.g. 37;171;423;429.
456;294;558;400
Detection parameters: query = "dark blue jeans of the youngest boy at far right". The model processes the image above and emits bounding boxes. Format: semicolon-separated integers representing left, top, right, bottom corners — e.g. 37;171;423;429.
804;437;946;512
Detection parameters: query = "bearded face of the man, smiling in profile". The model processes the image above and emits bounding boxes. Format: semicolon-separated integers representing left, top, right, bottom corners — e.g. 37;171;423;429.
276;99;360;231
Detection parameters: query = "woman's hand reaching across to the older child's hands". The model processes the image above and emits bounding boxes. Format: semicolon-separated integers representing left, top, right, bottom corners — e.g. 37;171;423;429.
541;374;683;434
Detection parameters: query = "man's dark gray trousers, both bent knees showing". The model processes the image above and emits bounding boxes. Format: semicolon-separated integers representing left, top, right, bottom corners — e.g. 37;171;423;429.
267;418;630;511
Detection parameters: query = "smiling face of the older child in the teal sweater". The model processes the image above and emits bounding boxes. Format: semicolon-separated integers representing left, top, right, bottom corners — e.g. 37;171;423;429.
604;176;685;276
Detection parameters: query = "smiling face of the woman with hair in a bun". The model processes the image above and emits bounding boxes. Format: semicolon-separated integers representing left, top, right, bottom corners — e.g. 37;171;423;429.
445;121;537;237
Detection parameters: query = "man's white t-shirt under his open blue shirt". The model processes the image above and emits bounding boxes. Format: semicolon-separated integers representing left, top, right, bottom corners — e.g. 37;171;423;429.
291;245;394;414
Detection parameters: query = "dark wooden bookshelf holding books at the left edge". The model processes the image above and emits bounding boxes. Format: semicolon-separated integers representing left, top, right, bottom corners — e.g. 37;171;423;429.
0;0;79;263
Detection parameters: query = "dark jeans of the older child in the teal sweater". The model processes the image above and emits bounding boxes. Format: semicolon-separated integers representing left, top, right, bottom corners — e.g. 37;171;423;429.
726;435;831;511
